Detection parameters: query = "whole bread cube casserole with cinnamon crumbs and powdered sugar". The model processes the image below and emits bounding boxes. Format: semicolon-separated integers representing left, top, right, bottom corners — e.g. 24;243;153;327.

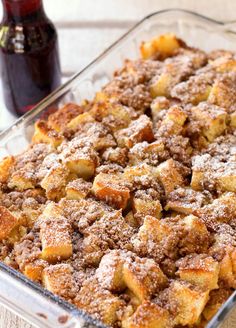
0;34;236;328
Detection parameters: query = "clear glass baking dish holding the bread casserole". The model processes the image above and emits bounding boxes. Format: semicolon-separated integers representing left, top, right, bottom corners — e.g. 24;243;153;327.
0;9;236;328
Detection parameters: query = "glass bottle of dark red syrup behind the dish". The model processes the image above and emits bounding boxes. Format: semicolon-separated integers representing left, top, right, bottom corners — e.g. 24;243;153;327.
0;0;61;116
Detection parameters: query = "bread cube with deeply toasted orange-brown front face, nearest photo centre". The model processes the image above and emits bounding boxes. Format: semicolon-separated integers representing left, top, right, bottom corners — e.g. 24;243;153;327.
92;173;130;209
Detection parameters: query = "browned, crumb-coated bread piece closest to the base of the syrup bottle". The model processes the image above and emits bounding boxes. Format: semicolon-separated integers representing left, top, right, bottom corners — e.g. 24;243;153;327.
48;103;84;132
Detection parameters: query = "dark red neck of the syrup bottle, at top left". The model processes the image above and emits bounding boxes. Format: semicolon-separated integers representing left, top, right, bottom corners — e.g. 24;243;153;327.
2;0;45;22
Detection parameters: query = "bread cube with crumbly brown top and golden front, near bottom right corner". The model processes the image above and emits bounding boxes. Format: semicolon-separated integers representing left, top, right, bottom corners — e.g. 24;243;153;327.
177;255;220;290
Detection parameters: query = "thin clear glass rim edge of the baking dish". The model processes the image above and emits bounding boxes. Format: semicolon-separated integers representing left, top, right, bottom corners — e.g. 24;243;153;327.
0;8;236;328
